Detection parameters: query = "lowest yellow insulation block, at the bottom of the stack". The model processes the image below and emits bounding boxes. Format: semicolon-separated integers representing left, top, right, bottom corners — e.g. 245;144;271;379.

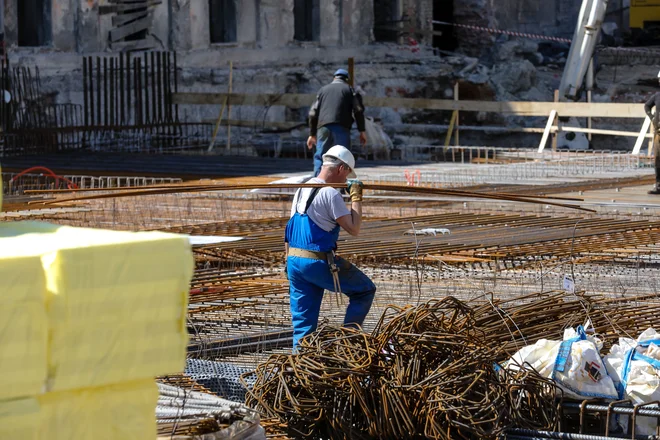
0;380;158;440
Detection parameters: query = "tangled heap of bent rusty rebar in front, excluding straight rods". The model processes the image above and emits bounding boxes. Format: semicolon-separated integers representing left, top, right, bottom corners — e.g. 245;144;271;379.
247;298;557;439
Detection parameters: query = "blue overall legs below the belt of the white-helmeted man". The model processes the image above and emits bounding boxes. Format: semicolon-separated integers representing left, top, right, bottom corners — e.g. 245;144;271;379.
287;256;376;350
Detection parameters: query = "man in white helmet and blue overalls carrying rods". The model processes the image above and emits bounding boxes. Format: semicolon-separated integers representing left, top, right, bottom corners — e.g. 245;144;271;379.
285;145;376;350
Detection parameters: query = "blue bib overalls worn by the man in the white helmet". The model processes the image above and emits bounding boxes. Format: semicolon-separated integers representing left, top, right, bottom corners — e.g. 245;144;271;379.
285;189;376;350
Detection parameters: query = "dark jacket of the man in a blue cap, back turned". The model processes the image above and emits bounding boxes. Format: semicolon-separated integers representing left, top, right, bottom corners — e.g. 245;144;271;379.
309;79;365;136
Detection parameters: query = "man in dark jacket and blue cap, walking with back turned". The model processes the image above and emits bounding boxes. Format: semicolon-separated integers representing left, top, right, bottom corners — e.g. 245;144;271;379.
307;69;367;177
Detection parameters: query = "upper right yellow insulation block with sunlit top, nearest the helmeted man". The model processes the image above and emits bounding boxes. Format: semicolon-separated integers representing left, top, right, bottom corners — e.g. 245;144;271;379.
0;222;193;391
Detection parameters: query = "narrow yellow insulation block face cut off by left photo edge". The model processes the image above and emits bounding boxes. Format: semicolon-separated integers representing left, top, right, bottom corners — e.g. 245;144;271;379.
0;256;48;400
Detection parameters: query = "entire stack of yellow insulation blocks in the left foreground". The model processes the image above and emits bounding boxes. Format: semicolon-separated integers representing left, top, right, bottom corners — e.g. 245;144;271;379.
0;222;193;440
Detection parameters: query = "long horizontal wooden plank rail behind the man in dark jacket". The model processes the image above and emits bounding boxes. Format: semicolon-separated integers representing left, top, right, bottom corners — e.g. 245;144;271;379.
174;93;646;119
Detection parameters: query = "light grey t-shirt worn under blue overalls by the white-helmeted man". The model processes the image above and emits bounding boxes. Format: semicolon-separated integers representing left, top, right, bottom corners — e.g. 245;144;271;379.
291;177;351;232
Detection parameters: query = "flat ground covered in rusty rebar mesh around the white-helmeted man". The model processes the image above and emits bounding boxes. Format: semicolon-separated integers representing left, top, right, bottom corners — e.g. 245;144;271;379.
2;147;660;438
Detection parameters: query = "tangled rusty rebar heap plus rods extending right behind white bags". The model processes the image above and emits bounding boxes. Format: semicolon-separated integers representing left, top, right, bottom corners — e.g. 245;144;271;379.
244;292;660;440
